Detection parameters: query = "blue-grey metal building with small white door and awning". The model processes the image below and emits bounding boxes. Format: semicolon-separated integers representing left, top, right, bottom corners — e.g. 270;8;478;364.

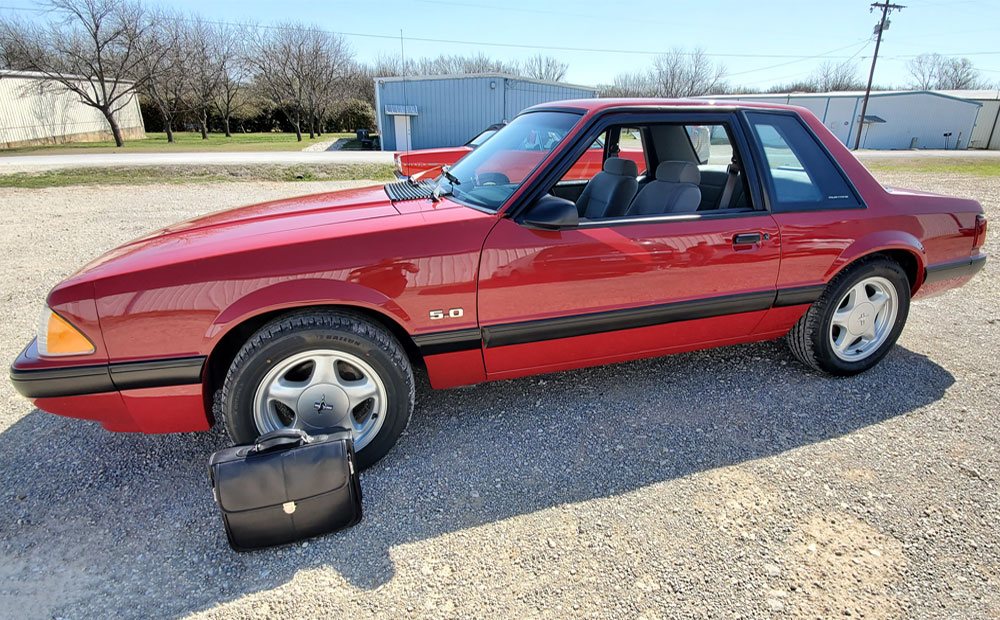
375;73;597;151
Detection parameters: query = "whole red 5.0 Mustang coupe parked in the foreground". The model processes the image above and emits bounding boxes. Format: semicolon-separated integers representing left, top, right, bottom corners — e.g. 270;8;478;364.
11;99;986;465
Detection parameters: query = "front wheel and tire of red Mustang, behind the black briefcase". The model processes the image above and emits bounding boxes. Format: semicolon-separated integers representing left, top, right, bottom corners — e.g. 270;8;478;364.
220;311;414;469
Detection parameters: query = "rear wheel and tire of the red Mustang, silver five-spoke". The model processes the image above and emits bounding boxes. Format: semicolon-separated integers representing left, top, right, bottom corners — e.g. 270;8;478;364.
787;255;910;376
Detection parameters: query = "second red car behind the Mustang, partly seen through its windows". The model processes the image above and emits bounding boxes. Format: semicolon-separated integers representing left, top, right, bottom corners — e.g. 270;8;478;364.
394;123;645;181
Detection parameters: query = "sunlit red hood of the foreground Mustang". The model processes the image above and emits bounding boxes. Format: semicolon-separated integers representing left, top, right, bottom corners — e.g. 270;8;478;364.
63;185;399;282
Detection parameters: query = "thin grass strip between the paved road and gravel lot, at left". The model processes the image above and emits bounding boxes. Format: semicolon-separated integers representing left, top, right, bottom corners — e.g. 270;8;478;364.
0;164;394;189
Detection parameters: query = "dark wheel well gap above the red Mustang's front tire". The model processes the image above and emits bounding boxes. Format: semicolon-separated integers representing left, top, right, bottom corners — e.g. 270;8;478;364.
204;305;424;423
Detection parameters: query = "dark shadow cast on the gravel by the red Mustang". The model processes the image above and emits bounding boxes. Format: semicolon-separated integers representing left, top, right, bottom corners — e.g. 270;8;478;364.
0;342;954;617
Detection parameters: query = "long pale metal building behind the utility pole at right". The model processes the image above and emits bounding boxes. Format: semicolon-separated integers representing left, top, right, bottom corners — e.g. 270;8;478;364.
710;90;980;149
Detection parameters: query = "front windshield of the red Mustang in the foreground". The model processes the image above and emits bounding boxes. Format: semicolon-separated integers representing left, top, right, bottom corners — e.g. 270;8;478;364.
438;112;580;211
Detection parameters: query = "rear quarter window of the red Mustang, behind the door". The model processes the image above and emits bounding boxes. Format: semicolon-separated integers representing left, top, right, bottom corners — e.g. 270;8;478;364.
747;112;860;210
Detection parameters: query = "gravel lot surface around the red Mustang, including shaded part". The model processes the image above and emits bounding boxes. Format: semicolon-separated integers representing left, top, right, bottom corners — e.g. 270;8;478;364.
0;173;1000;618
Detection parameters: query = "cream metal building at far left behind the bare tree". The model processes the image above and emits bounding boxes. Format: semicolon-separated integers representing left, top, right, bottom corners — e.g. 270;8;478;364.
0;71;146;148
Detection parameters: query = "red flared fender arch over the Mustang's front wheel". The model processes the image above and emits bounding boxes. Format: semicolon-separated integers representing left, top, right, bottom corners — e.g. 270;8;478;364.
205;278;409;346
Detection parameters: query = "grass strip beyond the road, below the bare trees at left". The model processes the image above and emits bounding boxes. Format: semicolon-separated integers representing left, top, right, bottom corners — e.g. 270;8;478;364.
0;131;354;157
